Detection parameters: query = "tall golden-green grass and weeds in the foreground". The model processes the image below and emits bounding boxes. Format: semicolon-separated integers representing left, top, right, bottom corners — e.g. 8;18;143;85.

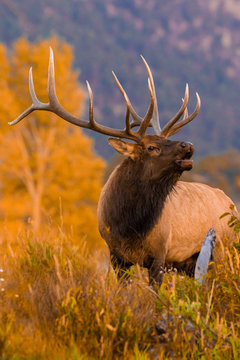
0;222;240;360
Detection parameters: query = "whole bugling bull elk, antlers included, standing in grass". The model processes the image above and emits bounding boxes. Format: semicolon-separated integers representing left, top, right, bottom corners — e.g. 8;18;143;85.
10;49;237;285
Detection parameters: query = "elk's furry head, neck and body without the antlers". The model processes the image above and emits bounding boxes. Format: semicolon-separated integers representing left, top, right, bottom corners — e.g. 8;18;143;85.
98;135;237;284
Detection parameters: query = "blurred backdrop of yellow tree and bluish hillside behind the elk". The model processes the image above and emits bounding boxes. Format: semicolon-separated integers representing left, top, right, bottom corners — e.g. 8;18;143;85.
0;0;240;243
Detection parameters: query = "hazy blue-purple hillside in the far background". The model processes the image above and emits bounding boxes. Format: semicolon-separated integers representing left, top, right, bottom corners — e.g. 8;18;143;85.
0;0;240;157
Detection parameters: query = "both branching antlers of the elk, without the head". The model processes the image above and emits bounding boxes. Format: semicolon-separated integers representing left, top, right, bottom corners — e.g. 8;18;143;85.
9;47;200;142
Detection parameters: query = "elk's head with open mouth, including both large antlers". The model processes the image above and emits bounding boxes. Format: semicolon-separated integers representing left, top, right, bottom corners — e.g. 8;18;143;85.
9;48;200;178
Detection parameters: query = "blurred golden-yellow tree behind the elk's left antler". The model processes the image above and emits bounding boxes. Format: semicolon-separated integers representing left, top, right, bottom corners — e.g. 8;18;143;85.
0;37;105;248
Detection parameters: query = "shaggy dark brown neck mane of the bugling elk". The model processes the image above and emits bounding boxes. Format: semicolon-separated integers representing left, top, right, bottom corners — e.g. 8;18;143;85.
102;158;179;242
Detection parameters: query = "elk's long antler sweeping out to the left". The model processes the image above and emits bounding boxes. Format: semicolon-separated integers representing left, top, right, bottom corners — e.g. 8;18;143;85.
9;47;155;142
